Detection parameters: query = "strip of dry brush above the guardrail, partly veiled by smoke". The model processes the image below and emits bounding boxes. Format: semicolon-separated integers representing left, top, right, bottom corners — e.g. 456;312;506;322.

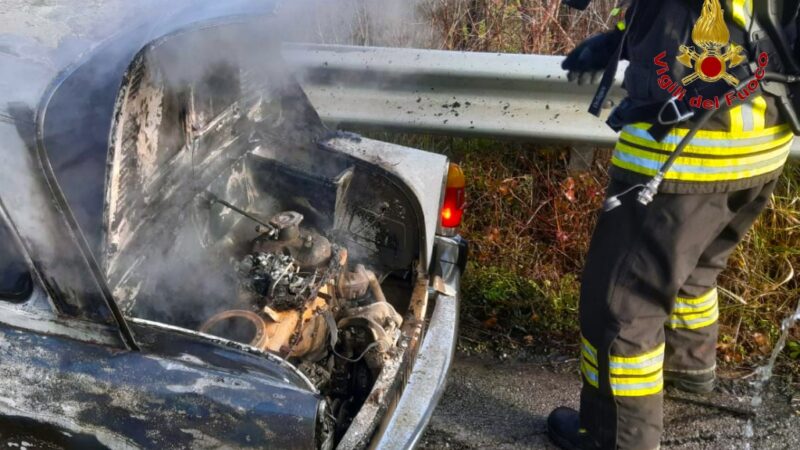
310;0;617;53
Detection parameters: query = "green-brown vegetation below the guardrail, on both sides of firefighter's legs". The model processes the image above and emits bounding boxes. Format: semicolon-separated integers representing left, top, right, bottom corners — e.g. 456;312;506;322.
452;144;800;368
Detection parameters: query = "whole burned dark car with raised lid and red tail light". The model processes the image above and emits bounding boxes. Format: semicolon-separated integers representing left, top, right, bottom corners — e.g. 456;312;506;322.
0;2;466;449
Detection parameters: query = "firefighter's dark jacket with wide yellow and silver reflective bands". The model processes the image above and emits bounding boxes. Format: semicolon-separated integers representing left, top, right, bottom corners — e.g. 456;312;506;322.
611;0;797;193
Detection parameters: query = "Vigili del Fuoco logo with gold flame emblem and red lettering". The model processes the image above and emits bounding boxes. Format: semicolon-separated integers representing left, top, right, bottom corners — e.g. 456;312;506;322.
653;0;769;109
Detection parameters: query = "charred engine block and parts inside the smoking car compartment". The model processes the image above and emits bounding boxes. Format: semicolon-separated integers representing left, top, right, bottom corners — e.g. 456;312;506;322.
200;211;403;416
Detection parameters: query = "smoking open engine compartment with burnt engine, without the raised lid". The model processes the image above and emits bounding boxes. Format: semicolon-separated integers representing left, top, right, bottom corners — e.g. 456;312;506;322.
109;142;428;441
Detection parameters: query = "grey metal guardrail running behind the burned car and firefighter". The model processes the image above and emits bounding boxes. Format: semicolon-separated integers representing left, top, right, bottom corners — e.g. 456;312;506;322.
284;44;800;158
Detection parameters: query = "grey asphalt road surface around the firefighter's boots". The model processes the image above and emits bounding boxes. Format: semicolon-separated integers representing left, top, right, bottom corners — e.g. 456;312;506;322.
421;355;800;450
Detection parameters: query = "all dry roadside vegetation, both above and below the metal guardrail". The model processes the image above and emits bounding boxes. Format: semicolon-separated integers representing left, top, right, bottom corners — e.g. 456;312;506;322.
356;0;800;367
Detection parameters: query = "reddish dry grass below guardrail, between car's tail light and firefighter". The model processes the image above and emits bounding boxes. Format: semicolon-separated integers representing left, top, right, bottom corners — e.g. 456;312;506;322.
455;146;607;344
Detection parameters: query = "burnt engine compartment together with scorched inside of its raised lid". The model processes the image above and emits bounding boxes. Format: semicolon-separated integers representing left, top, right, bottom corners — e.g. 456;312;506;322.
103;21;444;447
